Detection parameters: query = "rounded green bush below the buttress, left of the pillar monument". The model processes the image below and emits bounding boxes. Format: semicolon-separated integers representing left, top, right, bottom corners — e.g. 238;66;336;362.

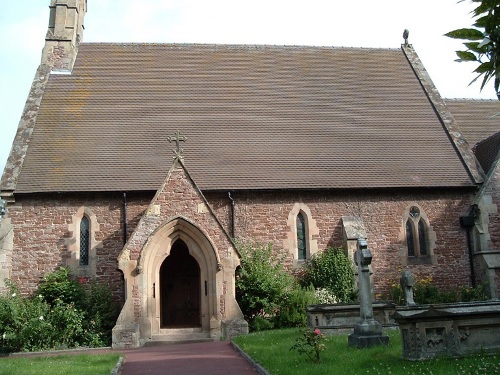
300;247;356;302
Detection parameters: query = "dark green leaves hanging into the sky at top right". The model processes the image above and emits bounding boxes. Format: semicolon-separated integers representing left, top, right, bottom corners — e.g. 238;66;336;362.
445;0;500;100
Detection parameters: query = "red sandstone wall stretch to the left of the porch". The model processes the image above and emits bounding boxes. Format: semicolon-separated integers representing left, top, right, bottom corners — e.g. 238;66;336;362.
5;194;151;302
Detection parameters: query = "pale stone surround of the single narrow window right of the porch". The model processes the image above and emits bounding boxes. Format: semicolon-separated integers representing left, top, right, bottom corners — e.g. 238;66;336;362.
283;203;319;268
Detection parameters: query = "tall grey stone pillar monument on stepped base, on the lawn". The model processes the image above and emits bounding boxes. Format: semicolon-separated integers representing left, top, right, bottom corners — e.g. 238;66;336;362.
348;239;389;348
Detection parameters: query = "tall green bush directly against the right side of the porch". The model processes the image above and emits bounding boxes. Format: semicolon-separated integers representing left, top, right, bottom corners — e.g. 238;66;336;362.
236;243;315;331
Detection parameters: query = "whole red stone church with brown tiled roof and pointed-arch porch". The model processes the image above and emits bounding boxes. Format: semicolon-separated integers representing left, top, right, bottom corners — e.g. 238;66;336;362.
0;0;500;348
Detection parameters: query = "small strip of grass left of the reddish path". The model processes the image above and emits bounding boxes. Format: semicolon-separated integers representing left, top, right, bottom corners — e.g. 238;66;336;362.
0;353;120;375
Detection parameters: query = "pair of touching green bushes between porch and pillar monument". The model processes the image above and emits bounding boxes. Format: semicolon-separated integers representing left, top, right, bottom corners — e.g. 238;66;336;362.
236;242;356;331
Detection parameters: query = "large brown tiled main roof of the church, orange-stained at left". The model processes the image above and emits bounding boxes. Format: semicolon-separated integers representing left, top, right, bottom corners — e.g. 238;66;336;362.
9;44;474;193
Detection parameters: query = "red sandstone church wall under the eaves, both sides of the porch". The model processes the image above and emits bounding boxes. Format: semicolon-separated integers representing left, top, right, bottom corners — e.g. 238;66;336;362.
9;192;470;300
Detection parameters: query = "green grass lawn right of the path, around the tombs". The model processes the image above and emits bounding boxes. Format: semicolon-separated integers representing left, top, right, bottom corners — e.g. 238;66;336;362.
233;329;500;375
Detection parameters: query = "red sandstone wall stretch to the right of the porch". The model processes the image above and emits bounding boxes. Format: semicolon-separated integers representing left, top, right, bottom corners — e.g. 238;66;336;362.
207;189;472;296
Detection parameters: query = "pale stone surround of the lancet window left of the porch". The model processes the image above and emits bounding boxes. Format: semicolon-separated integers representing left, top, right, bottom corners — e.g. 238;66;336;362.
66;206;102;277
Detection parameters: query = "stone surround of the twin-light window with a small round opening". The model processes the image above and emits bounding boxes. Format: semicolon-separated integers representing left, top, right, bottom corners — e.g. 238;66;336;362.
399;202;437;266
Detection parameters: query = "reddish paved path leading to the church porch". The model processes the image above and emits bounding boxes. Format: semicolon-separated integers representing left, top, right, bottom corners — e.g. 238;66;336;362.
120;341;258;375
